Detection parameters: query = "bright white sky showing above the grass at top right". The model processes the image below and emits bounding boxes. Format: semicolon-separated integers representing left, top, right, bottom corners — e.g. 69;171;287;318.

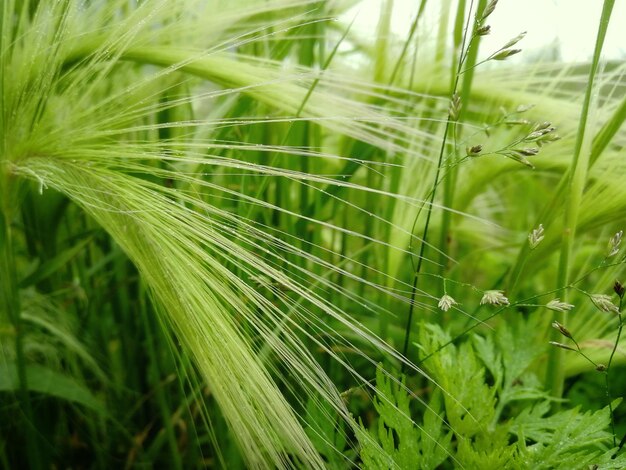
344;0;626;62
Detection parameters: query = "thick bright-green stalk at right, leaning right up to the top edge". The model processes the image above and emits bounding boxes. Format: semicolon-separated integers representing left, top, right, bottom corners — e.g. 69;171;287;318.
546;0;615;397
